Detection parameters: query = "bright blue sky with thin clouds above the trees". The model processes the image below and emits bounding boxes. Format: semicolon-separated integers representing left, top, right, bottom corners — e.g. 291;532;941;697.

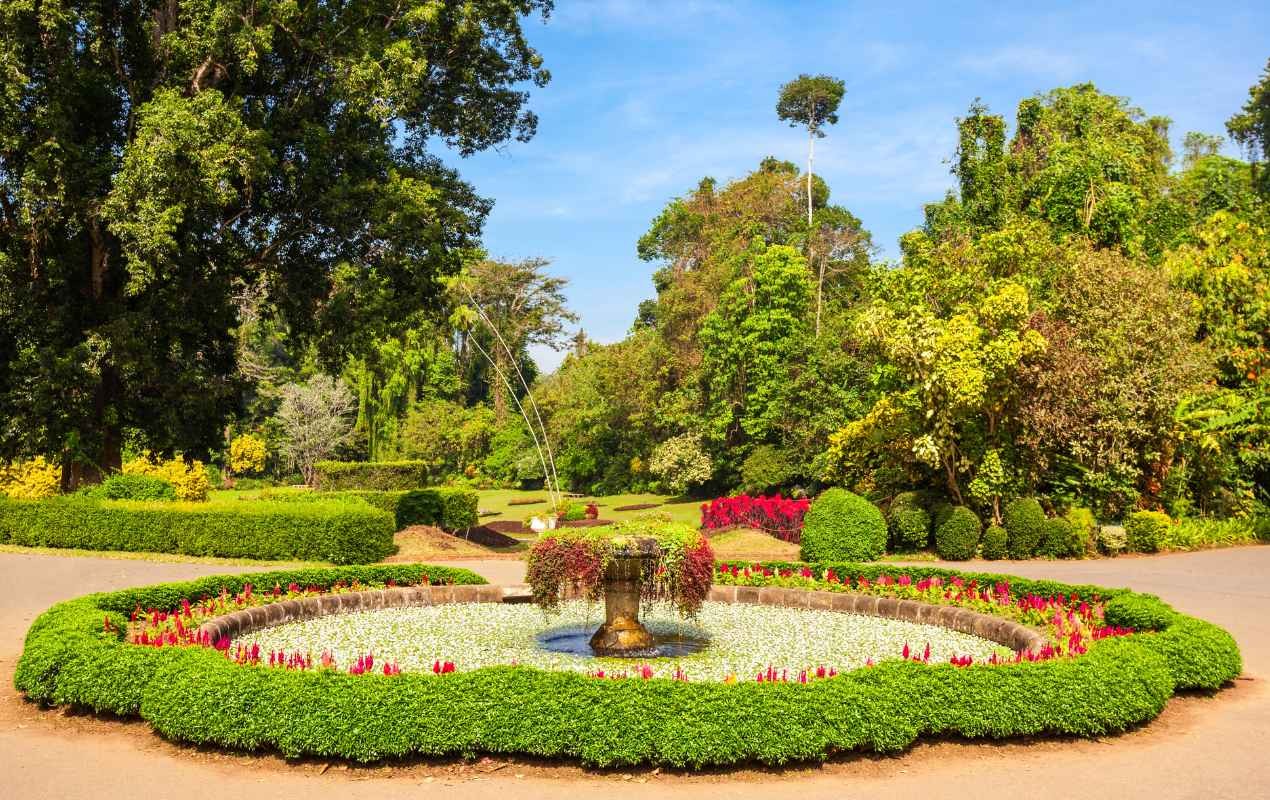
448;0;1270;370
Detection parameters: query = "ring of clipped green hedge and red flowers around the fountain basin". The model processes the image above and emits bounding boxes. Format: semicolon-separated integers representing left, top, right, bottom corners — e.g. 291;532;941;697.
15;564;1241;767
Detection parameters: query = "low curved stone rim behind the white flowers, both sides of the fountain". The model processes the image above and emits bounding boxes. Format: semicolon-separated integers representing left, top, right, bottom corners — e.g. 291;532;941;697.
198;584;1049;653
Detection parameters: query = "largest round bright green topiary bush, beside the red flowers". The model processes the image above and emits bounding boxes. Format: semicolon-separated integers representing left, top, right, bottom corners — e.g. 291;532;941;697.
799;489;886;561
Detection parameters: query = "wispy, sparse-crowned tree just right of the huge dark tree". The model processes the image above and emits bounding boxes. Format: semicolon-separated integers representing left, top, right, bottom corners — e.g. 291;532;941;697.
453;258;578;424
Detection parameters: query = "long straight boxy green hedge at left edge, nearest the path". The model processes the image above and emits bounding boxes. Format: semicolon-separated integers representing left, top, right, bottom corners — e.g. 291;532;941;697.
0;495;396;564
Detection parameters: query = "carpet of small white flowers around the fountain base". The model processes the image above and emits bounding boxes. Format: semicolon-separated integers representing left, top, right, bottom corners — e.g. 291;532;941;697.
236;602;1010;681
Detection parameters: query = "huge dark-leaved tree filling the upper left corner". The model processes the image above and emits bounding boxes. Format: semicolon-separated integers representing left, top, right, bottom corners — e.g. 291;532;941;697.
0;0;550;484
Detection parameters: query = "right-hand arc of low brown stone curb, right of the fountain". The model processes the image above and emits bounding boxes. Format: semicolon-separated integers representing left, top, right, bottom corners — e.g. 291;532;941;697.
707;587;1049;653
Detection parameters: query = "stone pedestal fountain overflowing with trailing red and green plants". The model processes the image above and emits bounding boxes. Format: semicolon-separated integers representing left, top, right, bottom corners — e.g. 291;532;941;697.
526;519;714;657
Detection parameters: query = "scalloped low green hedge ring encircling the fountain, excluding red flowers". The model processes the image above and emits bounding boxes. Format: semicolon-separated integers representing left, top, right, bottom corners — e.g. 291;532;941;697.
15;564;1240;767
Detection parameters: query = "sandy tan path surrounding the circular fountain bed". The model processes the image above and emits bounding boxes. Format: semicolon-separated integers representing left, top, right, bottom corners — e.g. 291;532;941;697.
0;547;1270;800
